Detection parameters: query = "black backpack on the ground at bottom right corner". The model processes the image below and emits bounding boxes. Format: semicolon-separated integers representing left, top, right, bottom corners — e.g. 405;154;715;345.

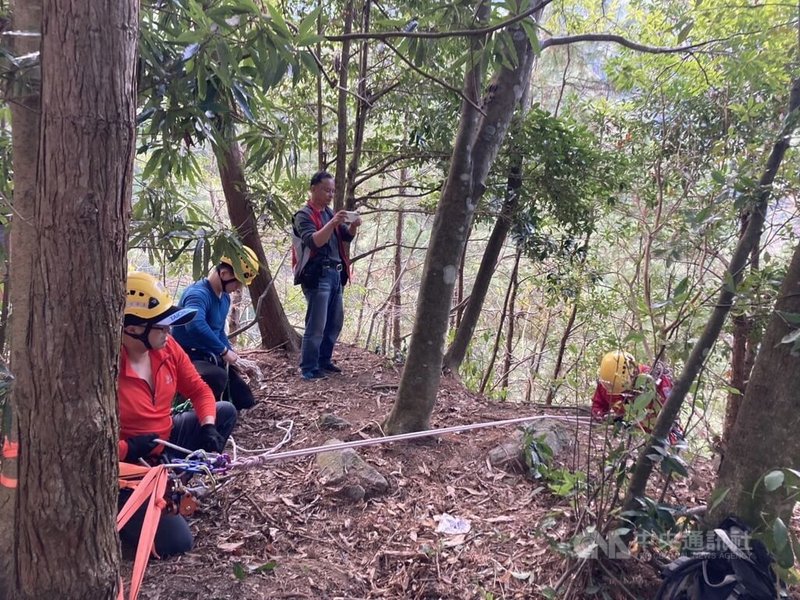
656;518;778;600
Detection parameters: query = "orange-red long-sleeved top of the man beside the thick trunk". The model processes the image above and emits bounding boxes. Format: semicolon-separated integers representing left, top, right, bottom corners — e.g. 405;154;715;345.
117;336;216;460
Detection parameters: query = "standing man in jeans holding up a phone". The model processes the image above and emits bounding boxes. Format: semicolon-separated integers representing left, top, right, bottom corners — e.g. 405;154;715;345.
293;171;361;380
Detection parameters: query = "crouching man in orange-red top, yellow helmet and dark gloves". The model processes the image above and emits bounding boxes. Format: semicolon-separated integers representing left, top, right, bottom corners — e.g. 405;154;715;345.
117;272;236;557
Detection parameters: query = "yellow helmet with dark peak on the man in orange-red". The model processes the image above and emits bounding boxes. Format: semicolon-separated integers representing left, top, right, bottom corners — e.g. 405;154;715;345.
124;271;197;327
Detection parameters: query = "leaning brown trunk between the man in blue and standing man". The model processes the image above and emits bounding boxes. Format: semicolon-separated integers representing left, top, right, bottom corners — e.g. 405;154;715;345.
217;127;300;352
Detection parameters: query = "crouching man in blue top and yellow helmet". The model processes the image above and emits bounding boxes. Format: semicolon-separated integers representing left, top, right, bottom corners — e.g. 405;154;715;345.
175;246;258;410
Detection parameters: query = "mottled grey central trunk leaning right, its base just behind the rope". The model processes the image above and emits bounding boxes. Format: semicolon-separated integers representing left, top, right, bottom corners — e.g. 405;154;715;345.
386;2;534;434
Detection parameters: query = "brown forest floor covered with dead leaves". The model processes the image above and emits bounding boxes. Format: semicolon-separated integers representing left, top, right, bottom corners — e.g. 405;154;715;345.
131;347;776;600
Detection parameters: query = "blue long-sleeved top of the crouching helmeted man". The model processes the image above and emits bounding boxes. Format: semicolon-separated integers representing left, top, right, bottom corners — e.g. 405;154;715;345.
172;279;231;358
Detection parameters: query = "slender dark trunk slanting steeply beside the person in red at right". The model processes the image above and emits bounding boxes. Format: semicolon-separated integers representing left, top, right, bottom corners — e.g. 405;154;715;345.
623;79;800;511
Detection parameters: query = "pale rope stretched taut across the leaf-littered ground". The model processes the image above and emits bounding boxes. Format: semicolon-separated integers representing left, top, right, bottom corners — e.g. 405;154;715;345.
230;415;592;468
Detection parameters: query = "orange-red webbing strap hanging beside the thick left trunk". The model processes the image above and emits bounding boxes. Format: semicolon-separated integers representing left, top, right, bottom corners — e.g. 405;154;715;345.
117;463;167;600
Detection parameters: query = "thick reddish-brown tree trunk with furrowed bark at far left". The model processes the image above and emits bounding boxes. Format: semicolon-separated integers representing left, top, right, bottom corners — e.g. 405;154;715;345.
0;0;138;600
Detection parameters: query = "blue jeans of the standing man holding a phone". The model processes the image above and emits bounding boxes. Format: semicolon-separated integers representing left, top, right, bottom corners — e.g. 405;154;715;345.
300;268;344;374
